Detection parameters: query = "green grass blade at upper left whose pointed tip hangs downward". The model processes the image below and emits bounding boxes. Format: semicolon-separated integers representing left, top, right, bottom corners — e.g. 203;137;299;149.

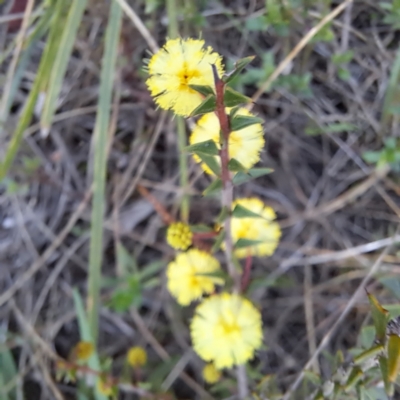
40;0;87;135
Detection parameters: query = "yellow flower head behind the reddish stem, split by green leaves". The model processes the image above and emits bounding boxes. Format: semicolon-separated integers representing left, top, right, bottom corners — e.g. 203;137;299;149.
189;108;265;174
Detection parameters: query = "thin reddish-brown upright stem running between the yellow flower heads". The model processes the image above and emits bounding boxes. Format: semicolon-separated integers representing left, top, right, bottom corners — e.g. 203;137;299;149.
211;65;241;293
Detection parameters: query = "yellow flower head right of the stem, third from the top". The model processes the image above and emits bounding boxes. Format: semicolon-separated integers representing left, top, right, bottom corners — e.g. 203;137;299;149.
231;198;281;258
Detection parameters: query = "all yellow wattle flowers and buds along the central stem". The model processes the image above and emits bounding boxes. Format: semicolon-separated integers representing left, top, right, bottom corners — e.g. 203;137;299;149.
146;39;281;372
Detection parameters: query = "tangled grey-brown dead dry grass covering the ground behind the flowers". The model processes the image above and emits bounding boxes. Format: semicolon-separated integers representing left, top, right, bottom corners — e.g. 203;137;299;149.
0;0;400;399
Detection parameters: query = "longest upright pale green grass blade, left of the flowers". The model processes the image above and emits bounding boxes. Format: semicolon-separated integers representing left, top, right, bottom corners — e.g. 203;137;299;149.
88;2;122;343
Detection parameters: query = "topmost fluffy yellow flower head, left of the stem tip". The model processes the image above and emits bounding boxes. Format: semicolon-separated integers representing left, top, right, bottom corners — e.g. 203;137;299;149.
146;39;224;116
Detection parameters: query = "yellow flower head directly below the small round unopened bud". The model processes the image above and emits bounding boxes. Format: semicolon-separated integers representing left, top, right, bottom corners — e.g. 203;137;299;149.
167;249;223;306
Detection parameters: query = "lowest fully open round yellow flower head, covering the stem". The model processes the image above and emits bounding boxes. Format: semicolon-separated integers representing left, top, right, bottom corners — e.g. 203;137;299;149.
190;293;262;369
